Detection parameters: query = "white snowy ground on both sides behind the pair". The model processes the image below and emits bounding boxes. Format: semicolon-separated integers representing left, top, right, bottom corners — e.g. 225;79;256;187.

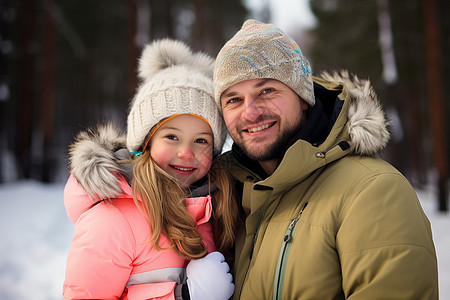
0;182;450;300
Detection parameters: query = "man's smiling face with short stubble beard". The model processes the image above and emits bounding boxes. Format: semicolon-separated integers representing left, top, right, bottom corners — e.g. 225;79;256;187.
220;79;308;161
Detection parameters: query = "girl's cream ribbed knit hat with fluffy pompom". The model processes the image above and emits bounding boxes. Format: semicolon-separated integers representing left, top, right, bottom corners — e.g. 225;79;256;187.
127;39;226;155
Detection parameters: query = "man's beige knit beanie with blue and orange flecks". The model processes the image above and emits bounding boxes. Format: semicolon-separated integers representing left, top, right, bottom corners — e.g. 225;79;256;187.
214;20;315;109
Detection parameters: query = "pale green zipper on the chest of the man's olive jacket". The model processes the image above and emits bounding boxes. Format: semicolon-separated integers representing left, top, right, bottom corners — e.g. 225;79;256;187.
272;202;308;300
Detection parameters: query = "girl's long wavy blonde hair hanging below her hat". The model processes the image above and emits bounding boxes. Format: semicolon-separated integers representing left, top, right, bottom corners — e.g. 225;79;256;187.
131;151;238;259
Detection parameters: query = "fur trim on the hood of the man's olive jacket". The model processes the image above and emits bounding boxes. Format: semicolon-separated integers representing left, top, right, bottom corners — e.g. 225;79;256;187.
320;71;390;156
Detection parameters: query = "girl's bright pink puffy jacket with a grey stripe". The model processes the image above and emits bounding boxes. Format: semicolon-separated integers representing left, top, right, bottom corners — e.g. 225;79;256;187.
63;175;215;300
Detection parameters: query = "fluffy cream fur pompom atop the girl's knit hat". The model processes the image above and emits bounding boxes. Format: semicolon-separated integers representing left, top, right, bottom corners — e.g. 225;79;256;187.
139;39;214;82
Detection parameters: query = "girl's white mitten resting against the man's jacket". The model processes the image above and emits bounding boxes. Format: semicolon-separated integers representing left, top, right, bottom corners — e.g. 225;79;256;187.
186;252;234;300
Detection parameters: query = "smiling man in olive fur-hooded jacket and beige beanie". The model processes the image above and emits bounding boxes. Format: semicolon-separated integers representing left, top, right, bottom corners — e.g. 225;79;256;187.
214;20;438;300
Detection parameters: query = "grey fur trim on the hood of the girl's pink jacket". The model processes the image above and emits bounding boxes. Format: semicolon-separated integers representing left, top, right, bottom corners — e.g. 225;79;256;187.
69;124;126;199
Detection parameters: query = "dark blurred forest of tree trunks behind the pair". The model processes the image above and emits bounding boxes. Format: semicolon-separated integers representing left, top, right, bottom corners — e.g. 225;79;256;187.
0;0;450;211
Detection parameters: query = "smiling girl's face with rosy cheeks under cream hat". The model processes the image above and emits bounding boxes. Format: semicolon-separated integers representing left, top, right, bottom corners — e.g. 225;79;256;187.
150;114;213;187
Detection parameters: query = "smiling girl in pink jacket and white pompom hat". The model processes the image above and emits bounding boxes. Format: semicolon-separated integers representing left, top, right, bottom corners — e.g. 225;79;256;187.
63;39;237;300
